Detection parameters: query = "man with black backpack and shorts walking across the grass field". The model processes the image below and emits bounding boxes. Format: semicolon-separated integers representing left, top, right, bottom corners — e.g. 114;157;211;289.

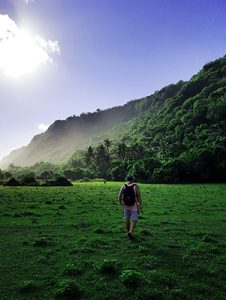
118;176;142;239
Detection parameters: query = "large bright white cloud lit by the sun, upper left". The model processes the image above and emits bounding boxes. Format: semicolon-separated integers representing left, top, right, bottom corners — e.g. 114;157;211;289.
0;14;60;78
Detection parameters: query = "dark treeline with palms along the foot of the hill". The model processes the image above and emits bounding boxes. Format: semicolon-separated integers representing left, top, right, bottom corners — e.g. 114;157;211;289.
61;139;226;183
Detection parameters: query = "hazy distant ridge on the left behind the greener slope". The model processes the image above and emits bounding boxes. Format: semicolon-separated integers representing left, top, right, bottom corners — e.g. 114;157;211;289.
0;101;139;168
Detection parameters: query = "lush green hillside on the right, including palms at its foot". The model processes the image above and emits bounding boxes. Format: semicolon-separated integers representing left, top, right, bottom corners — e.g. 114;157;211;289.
59;57;226;183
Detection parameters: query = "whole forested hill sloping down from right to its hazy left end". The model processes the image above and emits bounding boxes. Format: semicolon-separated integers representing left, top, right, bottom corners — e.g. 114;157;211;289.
0;56;226;181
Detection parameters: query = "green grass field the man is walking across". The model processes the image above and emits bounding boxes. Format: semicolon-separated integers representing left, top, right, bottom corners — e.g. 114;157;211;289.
0;182;226;300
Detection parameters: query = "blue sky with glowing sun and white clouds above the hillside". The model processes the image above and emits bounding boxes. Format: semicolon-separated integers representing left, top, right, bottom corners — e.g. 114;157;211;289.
0;0;226;159
